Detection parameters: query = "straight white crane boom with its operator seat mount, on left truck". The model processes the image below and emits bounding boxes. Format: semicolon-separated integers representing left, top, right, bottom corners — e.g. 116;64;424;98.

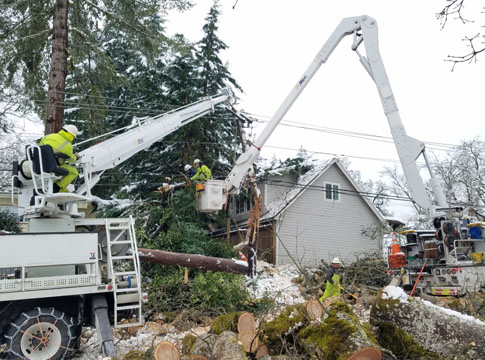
16;89;233;218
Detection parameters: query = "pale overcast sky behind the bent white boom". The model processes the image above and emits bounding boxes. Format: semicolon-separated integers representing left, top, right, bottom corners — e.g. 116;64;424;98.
167;0;485;217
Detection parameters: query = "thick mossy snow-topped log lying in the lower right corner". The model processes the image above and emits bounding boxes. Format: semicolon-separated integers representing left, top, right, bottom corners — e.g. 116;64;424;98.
371;286;485;359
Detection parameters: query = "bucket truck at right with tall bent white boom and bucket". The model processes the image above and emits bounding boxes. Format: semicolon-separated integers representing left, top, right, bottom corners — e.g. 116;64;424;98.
193;15;485;295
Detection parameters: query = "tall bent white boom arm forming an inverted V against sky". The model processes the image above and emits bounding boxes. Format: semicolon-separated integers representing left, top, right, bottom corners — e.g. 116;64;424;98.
219;15;447;212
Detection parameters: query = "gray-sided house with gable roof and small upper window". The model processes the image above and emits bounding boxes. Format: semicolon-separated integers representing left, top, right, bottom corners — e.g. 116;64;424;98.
223;159;386;266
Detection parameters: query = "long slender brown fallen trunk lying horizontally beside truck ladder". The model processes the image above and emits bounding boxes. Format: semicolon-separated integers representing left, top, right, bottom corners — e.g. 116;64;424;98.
138;249;248;275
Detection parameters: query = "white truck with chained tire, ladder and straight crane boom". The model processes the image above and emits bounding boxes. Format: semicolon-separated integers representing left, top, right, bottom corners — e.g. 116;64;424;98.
0;89;232;360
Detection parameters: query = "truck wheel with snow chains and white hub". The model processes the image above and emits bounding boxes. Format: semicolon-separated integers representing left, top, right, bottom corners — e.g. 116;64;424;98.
5;307;76;360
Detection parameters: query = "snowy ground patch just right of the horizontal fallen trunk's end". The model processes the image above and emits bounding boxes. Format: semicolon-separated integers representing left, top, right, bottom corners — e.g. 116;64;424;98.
248;261;305;305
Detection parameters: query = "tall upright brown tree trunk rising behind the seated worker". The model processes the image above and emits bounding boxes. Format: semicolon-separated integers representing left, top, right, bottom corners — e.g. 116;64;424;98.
45;0;69;134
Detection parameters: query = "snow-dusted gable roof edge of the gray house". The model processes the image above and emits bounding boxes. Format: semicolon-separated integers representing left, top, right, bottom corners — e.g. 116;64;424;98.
261;158;386;223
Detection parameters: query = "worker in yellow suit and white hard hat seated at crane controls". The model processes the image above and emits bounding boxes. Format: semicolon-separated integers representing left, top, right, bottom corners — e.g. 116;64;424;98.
39;125;79;192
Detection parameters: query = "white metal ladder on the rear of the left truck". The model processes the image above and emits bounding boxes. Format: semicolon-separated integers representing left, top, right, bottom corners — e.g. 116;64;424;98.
105;216;143;328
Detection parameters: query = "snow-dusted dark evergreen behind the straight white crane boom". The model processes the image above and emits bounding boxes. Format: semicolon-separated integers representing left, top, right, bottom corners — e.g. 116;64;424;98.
110;2;240;197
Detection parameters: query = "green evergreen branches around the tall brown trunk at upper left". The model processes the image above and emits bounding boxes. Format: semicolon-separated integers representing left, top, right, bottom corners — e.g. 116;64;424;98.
0;0;190;134
